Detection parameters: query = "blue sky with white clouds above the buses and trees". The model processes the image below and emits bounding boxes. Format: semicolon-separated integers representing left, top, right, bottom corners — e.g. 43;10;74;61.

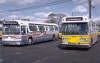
0;0;100;21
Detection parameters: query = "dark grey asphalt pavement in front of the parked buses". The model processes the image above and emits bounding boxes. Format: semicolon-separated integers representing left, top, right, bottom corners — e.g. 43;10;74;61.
1;38;100;63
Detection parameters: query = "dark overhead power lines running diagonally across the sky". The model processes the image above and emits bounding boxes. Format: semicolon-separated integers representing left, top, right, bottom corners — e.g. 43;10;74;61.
7;0;72;12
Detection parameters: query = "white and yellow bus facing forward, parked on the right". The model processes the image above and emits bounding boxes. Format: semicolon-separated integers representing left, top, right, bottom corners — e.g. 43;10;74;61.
61;16;98;48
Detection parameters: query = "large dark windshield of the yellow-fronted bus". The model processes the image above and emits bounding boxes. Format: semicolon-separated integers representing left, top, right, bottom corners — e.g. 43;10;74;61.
61;23;88;35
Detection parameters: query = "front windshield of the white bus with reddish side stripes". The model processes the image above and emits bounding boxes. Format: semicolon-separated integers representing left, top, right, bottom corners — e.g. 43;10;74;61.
3;25;20;35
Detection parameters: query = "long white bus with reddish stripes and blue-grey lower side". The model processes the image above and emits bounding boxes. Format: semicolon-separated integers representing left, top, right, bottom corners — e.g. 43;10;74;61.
1;20;59;45
